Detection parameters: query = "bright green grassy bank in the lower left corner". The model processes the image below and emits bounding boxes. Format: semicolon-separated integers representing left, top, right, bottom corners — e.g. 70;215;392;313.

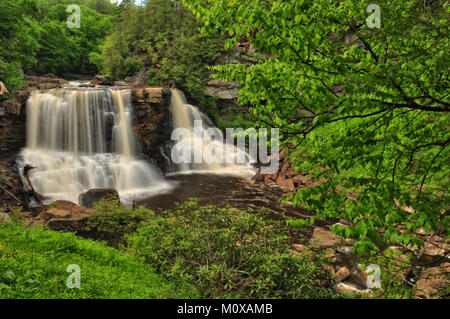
0;222;198;299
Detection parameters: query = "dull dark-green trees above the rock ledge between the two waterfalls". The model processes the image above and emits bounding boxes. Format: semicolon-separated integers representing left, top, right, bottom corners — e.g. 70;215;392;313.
97;0;223;102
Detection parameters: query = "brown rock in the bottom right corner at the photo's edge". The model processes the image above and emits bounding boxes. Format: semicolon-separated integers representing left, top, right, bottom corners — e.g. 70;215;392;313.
416;262;450;298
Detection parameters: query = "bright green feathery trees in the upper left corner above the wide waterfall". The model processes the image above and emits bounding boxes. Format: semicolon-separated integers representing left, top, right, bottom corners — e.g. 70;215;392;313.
0;0;116;90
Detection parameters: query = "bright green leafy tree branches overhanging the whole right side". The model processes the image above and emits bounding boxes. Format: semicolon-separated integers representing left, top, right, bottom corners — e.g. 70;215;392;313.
184;0;450;254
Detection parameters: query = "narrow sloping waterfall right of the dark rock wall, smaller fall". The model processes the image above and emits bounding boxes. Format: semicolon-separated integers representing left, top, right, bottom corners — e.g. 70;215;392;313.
170;89;255;177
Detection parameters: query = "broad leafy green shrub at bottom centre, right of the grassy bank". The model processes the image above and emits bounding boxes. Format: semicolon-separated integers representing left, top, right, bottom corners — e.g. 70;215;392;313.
127;200;335;298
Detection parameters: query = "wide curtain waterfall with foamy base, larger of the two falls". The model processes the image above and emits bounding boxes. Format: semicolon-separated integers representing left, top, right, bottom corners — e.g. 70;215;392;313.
18;88;172;204
